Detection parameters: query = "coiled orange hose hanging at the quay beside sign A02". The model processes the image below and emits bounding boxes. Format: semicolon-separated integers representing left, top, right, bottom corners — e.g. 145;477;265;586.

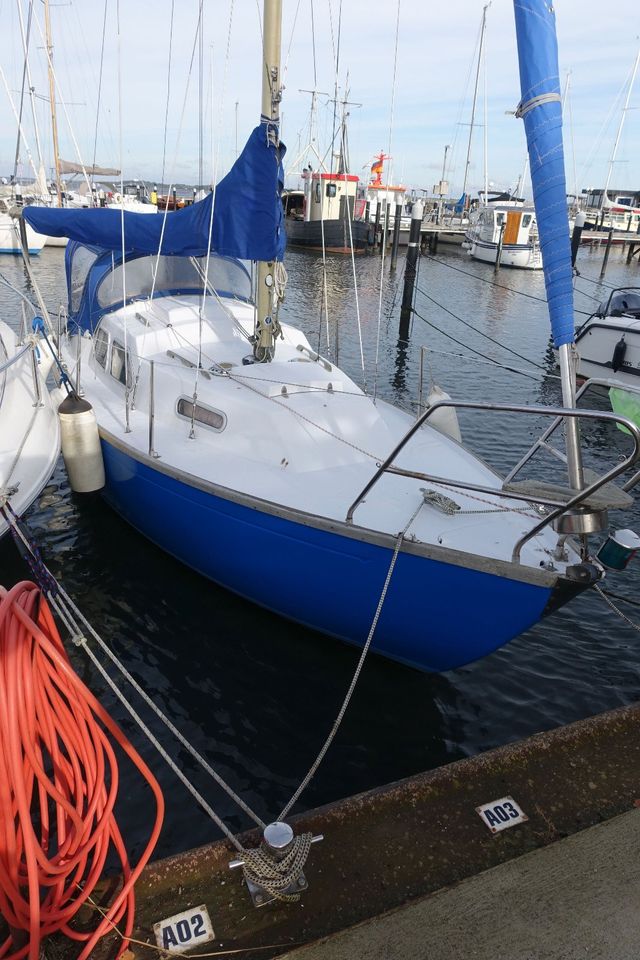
0;581;164;960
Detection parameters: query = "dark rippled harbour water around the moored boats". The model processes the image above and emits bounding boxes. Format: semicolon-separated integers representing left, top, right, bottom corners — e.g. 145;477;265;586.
0;247;640;856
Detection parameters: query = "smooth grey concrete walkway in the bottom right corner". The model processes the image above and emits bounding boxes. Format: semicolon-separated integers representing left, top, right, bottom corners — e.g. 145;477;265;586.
281;810;640;960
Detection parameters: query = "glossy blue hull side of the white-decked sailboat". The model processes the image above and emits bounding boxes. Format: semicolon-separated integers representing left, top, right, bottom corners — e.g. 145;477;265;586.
102;439;552;671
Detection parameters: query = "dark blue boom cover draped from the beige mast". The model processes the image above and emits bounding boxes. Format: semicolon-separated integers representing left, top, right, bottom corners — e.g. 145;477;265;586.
22;123;286;261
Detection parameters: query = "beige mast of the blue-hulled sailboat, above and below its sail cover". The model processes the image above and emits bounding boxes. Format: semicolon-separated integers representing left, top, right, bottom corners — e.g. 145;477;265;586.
253;0;282;363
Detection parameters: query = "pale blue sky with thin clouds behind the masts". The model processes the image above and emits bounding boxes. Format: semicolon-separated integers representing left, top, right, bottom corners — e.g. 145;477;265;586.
0;0;640;196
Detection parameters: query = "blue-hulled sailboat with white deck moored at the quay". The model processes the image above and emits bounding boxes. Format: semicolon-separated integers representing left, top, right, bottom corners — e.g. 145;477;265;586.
23;0;640;671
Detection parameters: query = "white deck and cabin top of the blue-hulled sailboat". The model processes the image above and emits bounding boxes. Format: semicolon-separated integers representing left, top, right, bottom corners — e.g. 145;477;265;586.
66;296;575;568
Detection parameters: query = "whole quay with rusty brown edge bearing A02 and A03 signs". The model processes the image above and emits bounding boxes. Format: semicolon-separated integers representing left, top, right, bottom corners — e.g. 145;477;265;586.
37;705;640;960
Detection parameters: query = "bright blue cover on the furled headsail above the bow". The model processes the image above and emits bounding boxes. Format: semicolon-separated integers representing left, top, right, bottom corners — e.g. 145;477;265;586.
513;0;574;347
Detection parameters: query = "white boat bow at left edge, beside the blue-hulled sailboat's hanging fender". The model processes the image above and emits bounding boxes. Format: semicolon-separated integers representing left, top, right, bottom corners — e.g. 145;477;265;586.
0;320;60;537
